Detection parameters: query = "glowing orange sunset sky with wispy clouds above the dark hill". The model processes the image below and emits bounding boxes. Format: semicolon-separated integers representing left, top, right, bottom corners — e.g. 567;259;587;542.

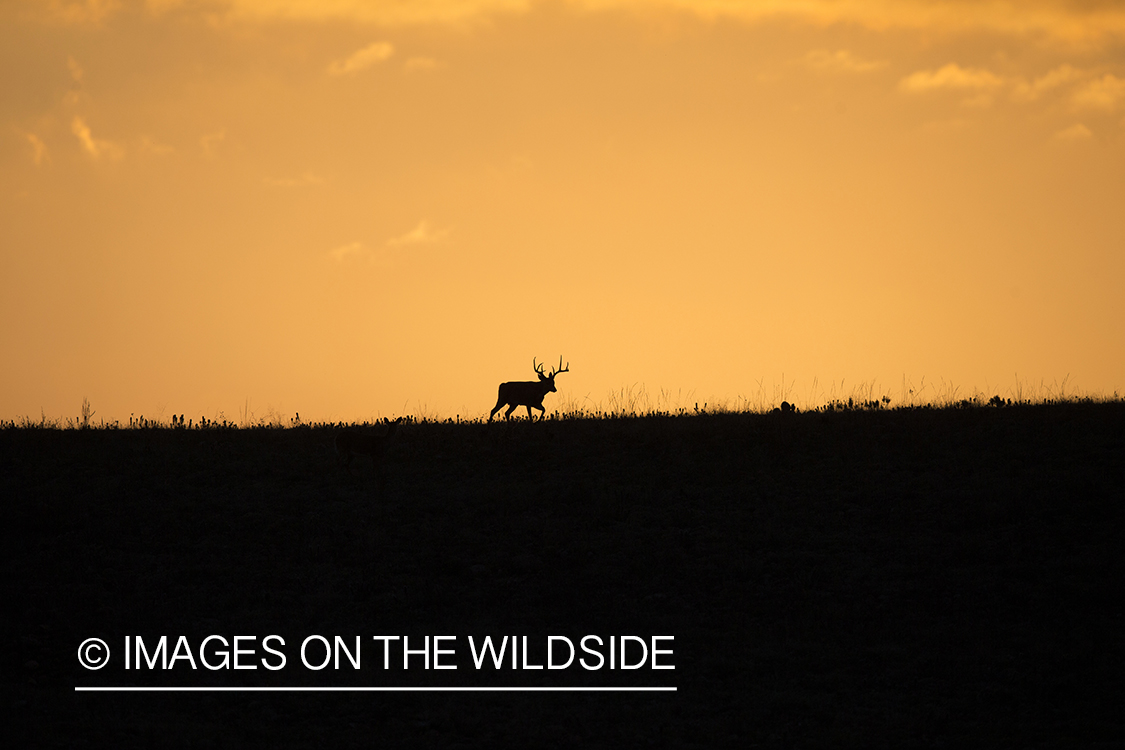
0;0;1125;421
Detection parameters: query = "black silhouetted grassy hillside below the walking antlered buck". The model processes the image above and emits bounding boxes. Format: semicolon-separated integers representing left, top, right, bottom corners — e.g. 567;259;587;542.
0;403;1125;748
